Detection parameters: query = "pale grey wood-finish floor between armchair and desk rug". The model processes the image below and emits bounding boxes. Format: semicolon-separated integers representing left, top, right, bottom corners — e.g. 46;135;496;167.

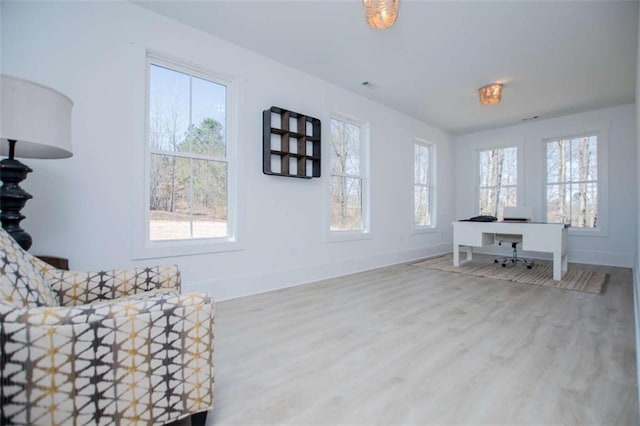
207;265;638;425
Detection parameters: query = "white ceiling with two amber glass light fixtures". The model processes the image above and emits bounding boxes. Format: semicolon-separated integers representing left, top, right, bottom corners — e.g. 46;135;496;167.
135;0;638;134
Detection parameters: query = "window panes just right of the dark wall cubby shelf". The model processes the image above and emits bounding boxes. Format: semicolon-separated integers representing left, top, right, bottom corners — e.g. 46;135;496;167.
329;118;367;232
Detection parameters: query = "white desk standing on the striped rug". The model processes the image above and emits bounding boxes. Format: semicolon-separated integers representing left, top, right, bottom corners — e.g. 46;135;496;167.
453;221;568;281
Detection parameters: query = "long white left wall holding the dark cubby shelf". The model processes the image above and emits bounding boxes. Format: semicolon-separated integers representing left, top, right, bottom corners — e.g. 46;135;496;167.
1;2;453;299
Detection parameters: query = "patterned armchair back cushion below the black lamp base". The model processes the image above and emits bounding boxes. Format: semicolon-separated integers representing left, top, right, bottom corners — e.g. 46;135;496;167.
0;228;57;308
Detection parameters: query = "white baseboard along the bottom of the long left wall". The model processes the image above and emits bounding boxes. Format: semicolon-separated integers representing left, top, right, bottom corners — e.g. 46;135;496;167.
182;244;451;301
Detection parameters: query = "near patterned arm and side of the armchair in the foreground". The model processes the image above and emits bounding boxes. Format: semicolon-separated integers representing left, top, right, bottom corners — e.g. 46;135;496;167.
0;290;215;426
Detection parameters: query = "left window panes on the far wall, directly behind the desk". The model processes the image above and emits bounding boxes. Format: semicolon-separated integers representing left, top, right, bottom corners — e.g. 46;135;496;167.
478;147;518;219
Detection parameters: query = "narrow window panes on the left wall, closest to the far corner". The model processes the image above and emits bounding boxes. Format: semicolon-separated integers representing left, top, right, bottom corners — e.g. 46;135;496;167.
413;141;435;229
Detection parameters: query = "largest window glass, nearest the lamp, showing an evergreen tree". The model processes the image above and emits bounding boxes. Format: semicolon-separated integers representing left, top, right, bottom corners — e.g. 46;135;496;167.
147;58;231;242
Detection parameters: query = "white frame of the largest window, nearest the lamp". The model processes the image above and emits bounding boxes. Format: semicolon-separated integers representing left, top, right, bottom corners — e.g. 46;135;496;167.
133;50;243;259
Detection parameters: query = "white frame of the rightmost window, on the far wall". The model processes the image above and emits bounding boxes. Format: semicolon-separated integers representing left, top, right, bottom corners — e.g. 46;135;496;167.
541;130;609;237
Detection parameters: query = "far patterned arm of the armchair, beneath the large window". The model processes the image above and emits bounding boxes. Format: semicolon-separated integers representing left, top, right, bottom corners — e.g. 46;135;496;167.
38;261;181;306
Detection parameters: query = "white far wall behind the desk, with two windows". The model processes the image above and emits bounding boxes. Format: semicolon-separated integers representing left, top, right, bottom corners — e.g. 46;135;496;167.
455;105;638;267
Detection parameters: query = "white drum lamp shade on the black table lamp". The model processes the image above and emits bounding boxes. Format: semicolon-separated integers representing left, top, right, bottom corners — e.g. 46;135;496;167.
0;75;73;158
